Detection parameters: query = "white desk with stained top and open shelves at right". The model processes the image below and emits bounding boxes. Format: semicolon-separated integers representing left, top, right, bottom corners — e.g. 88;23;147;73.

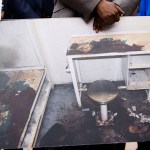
67;32;150;106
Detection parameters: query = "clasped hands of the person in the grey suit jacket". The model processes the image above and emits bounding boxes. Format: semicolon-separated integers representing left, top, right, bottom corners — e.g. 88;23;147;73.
93;0;124;32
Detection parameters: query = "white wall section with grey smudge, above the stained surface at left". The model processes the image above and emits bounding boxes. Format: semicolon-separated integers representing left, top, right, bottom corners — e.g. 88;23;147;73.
0;21;42;69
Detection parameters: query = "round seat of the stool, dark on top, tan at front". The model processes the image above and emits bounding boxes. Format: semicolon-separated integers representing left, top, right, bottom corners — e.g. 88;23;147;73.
87;80;118;104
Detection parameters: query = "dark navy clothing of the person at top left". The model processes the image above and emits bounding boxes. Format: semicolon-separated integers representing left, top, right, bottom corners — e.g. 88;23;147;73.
4;0;54;19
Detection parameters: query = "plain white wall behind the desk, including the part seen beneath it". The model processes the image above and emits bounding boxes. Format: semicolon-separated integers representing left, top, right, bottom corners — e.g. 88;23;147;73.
31;17;150;84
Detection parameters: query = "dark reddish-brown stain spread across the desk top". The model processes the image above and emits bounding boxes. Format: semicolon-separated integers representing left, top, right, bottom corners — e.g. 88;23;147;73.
67;38;143;55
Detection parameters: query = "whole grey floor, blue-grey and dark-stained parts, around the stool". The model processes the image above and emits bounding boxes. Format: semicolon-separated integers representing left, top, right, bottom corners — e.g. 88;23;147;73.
36;85;150;147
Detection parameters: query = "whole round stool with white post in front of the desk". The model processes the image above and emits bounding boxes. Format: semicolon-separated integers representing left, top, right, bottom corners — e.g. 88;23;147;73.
87;80;118;124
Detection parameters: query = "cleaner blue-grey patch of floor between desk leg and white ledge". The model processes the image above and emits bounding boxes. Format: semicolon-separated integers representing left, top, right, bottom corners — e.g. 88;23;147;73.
36;85;77;146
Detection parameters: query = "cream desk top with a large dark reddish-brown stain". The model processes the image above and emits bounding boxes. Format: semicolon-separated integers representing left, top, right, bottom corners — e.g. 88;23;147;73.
67;33;150;55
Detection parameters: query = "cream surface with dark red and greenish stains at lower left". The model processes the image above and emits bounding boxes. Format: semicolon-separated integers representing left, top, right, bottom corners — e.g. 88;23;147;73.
0;70;44;148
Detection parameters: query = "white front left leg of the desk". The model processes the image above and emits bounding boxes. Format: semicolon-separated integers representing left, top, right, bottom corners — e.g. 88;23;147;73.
68;58;81;107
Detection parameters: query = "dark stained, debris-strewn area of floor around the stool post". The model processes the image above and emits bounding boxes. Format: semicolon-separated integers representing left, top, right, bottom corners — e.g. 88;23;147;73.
41;86;150;147
